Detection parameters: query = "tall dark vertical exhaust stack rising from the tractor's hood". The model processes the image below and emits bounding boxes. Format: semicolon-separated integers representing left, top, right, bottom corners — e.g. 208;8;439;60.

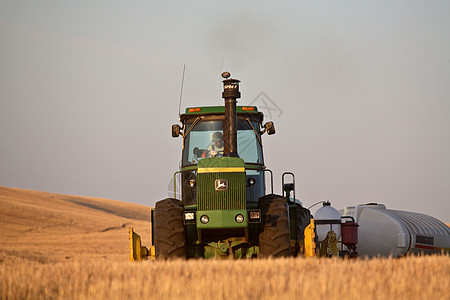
222;72;241;157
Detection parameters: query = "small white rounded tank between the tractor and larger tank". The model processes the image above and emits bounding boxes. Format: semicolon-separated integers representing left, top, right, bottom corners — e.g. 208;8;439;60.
314;202;341;242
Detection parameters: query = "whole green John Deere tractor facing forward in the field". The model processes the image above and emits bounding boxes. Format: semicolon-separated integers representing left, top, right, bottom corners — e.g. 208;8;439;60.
130;72;316;260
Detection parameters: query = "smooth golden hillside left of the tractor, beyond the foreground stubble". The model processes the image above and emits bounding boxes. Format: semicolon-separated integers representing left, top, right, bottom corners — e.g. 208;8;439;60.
0;187;150;263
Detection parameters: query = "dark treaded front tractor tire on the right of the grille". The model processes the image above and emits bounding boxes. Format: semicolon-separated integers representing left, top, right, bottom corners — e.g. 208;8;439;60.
258;195;291;258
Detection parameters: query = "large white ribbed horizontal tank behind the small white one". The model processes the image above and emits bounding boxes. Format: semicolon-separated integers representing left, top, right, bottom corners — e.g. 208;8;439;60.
340;203;450;257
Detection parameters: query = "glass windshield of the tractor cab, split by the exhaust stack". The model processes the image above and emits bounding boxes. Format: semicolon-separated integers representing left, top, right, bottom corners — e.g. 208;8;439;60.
183;120;263;166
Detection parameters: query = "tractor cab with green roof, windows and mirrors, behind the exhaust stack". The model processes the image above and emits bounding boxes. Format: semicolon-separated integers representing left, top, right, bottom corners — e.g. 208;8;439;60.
172;106;275;204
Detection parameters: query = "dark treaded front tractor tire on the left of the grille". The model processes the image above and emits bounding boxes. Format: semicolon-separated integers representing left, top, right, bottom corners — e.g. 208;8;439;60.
154;198;186;260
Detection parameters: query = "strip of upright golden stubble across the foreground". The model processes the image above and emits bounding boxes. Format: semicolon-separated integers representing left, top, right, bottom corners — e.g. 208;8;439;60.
0;256;450;299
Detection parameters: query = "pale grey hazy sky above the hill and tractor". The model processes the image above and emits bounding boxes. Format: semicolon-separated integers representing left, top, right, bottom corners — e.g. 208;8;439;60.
0;0;450;222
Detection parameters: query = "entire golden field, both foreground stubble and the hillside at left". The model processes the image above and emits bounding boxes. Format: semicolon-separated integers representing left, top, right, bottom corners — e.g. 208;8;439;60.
0;187;450;299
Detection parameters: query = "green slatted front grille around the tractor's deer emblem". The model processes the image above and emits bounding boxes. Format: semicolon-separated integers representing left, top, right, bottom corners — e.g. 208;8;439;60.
197;172;246;210
